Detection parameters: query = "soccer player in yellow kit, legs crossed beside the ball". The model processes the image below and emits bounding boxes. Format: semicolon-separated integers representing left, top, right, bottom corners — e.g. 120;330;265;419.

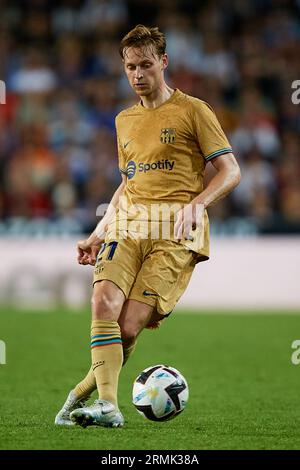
55;25;240;427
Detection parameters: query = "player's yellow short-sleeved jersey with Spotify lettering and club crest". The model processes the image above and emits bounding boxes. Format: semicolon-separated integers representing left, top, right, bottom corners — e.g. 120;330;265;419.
112;89;232;261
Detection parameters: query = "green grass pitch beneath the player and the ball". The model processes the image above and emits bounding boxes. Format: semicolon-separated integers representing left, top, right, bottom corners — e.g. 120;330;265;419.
0;308;300;450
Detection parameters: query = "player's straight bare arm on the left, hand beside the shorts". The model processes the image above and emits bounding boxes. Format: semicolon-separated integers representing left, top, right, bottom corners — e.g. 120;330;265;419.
77;174;126;265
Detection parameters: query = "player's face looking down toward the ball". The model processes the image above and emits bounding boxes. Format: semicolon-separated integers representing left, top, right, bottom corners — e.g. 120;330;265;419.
124;47;168;96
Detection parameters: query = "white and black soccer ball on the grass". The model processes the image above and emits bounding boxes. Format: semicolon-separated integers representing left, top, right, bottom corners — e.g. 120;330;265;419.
132;365;189;421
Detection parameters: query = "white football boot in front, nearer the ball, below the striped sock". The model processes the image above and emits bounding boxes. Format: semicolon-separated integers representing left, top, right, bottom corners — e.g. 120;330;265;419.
70;399;124;428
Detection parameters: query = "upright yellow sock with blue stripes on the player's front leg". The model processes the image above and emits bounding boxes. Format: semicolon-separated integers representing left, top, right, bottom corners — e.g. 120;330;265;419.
91;320;123;407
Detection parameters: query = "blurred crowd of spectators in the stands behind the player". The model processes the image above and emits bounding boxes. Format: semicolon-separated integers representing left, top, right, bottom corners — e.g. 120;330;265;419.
0;0;300;233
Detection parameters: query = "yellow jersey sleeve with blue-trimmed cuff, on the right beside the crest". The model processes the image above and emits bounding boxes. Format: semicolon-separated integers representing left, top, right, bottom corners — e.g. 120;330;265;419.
194;100;232;162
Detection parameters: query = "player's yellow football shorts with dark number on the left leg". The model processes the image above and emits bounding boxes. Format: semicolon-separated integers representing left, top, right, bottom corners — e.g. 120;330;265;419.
94;237;197;316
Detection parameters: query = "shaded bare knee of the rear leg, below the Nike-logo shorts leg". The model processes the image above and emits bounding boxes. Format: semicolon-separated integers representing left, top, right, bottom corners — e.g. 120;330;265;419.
118;300;154;339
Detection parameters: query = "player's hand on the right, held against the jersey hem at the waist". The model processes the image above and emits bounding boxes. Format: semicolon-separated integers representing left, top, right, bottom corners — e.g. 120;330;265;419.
174;202;204;240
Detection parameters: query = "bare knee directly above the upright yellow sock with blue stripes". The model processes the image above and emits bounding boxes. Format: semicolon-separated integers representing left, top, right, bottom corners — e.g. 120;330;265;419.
92;280;125;321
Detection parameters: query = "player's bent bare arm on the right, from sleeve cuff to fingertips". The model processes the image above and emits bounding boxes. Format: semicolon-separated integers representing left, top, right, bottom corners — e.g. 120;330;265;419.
174;153;241;240
